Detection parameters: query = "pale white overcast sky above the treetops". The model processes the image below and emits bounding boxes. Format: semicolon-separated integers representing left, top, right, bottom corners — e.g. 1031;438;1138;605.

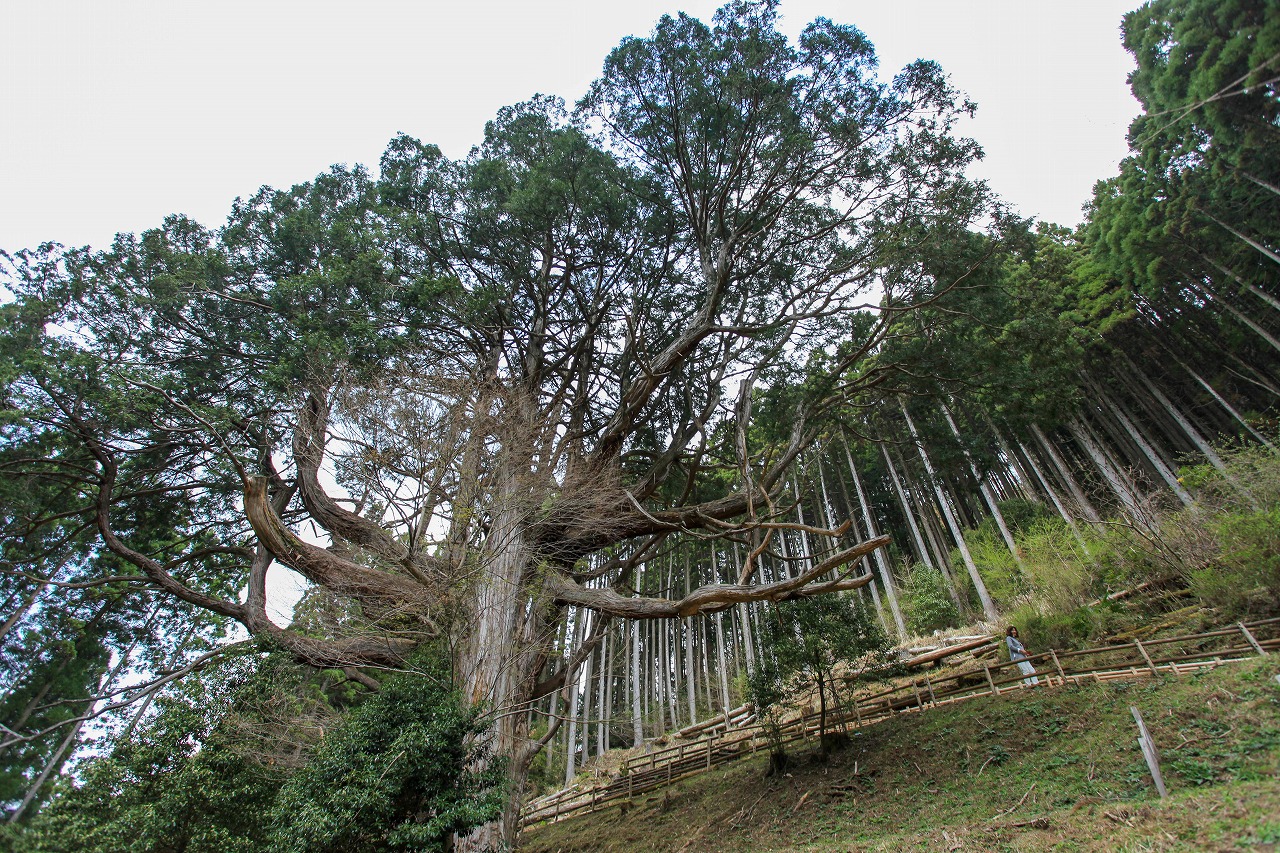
0;0;1138;251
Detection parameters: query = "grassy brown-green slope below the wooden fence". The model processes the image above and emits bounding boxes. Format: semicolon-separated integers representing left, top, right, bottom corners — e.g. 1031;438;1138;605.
520;654;1280;853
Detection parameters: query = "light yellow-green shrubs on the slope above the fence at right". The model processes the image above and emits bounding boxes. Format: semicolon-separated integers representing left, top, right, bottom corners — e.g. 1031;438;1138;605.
970;447;1280;622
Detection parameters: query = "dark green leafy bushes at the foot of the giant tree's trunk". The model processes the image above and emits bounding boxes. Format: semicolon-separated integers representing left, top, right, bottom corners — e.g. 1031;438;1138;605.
12;645;503;853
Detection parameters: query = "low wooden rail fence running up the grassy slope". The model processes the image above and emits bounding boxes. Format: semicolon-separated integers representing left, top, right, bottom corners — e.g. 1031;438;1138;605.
521;619;1280;826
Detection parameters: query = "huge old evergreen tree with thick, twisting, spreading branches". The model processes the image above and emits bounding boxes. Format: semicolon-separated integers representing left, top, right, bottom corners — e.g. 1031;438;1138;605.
4;1;986;844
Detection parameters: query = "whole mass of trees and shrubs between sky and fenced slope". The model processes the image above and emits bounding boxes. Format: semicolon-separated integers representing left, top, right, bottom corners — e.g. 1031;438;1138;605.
0;0;1280;853
